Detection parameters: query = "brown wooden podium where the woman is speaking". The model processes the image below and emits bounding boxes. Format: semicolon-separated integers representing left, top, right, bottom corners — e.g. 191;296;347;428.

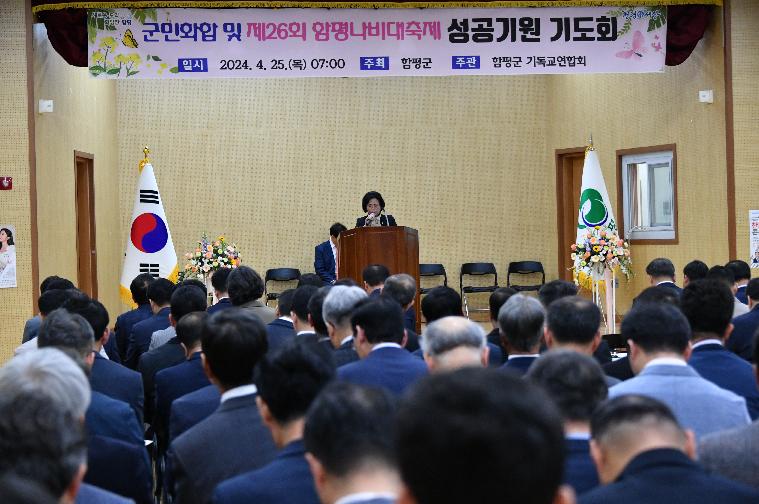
337;226;422;333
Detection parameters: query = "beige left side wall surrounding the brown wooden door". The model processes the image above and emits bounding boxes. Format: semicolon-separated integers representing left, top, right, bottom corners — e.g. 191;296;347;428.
34;24;123;323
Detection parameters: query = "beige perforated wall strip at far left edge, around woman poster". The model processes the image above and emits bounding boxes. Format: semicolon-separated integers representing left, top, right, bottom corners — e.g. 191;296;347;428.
0;0;33;362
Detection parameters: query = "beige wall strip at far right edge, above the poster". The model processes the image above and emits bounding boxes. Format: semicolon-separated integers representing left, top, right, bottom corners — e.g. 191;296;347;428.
731;0;759;268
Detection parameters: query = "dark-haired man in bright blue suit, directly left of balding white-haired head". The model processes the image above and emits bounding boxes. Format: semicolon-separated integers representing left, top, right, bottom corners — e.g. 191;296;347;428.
337;297;427;395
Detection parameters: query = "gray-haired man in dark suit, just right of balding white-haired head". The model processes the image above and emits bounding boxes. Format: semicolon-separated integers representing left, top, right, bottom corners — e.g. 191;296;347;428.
498;294;546;376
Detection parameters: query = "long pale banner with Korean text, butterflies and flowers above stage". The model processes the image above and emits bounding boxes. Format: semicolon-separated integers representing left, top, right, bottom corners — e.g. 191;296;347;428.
87;7;667;79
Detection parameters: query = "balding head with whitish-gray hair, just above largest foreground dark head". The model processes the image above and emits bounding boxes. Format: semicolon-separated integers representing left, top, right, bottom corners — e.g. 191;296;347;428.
421;317;490;372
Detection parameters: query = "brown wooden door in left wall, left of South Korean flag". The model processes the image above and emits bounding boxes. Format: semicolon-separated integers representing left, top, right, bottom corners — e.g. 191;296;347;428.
74;151;98;298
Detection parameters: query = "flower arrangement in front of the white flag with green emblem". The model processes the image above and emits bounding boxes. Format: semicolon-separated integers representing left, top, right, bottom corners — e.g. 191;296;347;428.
570;226;632;280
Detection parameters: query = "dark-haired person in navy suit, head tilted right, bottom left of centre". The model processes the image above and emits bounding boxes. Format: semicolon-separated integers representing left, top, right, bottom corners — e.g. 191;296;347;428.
213;341;334;504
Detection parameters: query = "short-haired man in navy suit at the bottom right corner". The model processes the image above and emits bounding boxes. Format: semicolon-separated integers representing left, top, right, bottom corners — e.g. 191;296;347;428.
580;396;759;504
